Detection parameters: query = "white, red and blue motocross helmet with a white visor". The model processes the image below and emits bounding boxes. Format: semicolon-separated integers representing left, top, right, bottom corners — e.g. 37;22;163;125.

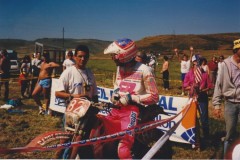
104;38;137;63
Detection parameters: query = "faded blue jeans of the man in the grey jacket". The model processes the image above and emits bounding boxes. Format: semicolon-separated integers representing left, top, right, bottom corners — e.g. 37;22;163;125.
224;101;240;141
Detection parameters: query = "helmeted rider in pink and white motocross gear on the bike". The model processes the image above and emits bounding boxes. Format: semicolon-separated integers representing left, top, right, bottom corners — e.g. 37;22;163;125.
104;38;159;159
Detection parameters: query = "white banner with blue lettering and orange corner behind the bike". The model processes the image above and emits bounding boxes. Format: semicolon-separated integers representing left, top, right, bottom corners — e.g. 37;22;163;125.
50;78;196;144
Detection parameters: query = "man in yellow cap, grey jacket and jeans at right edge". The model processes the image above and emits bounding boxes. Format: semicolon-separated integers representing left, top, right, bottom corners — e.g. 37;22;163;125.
212;39;240;154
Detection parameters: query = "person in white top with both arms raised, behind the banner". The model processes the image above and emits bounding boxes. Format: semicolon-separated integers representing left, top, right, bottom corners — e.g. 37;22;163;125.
174;47;193;96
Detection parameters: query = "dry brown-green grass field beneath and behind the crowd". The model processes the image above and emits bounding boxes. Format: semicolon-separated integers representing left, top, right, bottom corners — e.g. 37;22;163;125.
0;51;239;159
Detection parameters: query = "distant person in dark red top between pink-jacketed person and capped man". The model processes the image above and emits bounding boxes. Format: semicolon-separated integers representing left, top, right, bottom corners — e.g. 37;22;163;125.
208;55;218;85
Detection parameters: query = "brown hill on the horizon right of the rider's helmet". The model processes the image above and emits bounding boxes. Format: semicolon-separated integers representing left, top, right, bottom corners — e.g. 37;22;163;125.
137;33;240;52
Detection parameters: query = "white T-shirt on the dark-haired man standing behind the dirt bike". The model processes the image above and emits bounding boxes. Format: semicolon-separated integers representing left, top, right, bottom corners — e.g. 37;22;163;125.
57;66;98;98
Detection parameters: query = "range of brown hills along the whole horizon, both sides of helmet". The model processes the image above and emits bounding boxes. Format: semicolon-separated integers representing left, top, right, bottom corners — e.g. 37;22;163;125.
0;33;240;54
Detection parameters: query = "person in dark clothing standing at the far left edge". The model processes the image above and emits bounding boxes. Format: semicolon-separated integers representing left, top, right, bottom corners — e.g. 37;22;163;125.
0;49;11;101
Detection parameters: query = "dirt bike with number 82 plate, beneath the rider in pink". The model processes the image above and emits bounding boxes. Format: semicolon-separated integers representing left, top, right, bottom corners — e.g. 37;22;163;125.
27;98;172;159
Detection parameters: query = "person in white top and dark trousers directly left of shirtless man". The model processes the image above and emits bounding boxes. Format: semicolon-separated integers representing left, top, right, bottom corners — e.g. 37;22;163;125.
30;52;42;97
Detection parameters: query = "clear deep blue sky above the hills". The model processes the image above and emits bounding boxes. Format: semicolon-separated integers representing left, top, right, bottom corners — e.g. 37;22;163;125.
0;0;240;41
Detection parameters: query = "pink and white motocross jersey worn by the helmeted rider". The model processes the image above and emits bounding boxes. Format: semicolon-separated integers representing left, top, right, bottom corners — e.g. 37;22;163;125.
114;62;159;105
